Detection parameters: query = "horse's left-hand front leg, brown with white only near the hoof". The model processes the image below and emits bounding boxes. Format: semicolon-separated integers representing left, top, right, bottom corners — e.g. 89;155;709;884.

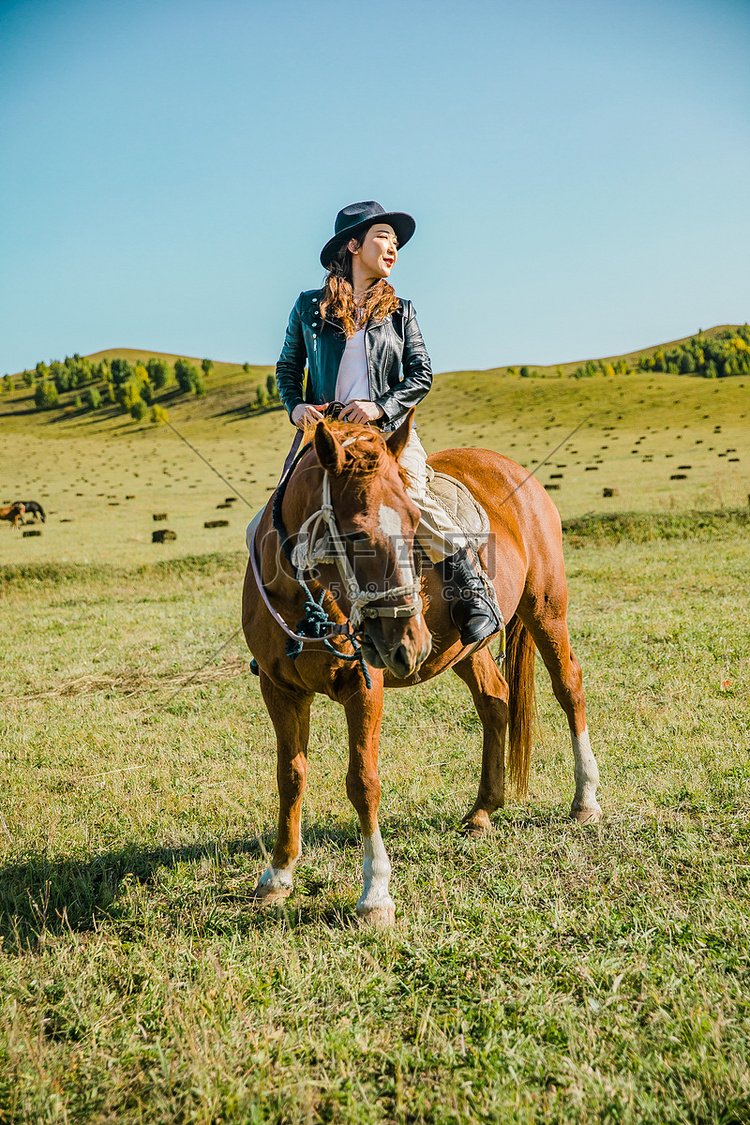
254;672;313;902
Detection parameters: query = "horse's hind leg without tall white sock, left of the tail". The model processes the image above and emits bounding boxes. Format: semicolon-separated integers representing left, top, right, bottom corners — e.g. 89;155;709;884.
453;648;508;836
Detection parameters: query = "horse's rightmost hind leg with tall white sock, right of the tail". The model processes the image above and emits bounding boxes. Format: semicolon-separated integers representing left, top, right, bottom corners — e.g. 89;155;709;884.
524;599;602;825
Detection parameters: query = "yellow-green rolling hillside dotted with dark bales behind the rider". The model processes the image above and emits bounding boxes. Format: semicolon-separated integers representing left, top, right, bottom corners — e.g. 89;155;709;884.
0;327;750;564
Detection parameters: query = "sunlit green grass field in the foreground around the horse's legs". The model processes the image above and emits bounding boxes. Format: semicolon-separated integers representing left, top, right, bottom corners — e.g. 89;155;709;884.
0;522;750;1125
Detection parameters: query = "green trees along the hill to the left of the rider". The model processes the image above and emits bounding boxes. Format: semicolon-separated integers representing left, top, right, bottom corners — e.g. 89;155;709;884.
2;352;280;423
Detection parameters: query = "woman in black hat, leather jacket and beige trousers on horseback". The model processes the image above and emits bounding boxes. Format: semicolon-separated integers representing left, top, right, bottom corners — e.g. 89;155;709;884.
275;200;501;646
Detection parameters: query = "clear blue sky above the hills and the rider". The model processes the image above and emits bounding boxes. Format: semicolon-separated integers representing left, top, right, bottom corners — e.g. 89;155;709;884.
0;0;750;375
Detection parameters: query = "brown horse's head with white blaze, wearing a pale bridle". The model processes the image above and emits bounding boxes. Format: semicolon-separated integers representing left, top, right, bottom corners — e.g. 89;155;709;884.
296;412;432;680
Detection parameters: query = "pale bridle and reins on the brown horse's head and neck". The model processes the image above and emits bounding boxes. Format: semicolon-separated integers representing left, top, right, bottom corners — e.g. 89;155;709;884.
250;438;423;644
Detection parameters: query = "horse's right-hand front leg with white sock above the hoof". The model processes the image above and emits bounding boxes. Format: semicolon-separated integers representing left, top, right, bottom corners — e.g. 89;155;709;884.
337;671;396;926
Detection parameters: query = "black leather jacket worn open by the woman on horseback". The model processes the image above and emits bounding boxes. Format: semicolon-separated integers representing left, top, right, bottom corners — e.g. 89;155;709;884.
275;289;432;430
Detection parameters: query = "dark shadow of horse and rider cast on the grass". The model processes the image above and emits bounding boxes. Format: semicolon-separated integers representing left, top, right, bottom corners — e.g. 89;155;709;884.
0;808;569;954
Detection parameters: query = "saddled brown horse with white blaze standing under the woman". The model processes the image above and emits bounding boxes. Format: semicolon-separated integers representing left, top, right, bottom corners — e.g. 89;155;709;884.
243;414;600;923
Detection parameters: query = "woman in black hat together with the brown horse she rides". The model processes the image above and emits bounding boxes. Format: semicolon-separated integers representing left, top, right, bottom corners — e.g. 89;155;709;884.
243;203;600;924
